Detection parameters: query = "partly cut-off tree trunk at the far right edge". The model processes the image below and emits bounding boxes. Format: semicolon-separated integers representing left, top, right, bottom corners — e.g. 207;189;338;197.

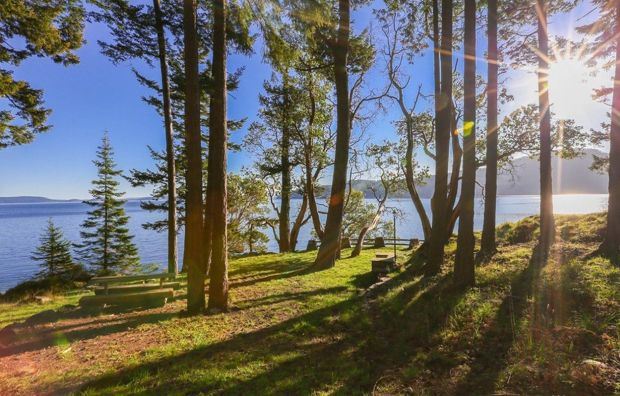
601;0;620;265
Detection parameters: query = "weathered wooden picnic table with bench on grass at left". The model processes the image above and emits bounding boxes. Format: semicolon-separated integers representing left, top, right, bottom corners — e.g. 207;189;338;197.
80;272;180;307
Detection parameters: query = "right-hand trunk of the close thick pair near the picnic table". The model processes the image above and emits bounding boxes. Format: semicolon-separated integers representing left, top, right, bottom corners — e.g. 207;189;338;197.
207;0;228;311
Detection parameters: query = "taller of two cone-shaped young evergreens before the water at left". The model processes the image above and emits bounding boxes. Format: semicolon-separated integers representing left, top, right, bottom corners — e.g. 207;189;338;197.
77;134;139;274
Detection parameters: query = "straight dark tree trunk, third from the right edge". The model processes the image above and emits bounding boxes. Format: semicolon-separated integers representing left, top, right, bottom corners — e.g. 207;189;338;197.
480;0;498;258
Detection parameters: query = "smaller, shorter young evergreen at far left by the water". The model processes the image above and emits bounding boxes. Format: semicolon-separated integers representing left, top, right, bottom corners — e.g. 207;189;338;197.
31;219;76;278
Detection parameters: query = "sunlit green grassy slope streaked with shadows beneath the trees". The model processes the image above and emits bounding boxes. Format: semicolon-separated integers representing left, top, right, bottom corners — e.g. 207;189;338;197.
0;216;620;395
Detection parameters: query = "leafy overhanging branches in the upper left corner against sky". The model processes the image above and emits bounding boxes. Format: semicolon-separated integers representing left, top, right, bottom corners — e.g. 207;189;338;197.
0;0;84;149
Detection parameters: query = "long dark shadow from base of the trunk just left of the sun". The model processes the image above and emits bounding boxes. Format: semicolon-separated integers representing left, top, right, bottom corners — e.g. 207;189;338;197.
455;246;545;394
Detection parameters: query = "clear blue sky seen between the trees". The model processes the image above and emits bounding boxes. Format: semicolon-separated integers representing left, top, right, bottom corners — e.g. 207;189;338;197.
0;0;608;198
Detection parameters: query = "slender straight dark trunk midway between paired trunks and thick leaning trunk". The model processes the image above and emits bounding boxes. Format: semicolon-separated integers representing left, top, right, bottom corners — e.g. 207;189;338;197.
279;81;292;253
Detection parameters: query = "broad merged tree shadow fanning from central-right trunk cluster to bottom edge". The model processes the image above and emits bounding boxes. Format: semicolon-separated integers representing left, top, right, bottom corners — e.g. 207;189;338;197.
71;255;470;395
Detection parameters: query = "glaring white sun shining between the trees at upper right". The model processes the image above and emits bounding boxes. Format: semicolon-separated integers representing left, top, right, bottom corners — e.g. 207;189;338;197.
549;58;597;118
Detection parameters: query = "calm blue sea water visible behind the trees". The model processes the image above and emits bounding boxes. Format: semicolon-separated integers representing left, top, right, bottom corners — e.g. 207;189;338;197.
0;195;607;292
